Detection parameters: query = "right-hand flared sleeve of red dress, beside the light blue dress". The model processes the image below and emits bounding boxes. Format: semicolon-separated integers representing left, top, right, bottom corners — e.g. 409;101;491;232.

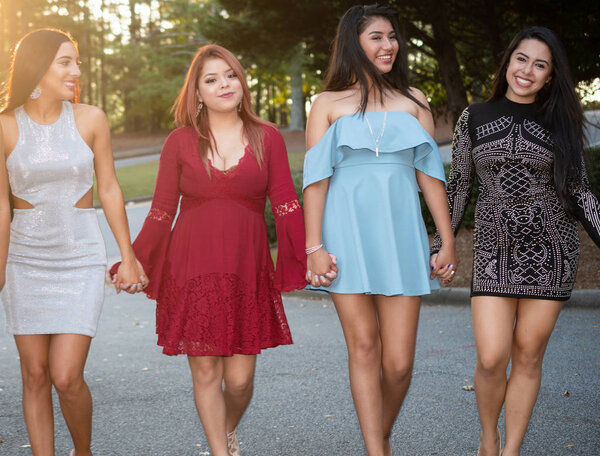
265;128;306;292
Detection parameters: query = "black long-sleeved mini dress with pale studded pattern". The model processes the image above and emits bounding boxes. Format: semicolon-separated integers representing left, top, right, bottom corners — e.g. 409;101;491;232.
432;98;600;301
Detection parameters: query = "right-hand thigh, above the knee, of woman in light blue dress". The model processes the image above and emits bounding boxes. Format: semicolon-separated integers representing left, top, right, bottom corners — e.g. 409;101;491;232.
375;295;421;358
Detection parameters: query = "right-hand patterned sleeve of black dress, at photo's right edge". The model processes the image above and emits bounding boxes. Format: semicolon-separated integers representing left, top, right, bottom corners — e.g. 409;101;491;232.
569;156;600;248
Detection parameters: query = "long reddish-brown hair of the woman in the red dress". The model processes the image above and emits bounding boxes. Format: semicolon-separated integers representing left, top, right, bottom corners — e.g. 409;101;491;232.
172;44;274;171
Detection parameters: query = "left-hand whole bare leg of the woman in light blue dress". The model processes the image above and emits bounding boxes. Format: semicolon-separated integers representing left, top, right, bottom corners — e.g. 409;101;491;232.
331;293;384;456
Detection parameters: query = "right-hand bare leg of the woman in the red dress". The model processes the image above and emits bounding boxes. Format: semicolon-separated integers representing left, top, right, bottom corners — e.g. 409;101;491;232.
223;355;256;432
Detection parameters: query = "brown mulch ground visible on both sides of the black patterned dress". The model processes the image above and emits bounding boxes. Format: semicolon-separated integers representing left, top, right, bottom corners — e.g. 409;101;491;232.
434;227;600;289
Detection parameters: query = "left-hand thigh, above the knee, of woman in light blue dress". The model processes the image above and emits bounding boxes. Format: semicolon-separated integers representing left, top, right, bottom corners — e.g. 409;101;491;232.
331;293;379;348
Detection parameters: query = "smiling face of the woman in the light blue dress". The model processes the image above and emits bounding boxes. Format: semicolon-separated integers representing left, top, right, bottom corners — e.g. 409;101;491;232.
358;17;398;74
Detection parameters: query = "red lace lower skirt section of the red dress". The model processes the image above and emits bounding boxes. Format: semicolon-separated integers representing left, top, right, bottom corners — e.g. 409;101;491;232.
156;269;292;356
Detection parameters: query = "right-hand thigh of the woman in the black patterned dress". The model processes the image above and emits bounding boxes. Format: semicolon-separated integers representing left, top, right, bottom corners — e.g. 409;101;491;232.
514;299;564;355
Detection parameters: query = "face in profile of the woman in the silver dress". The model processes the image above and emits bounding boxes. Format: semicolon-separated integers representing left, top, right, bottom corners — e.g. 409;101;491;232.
38;41;81;100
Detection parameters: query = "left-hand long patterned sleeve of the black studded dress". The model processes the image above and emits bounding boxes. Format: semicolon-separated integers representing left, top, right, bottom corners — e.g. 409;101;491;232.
431;108;475;255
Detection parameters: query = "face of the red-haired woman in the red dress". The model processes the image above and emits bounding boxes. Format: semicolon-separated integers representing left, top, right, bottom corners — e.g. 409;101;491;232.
198;58;244;112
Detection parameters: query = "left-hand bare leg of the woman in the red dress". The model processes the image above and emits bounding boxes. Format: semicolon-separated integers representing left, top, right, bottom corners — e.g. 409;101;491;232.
188;356;229;456
